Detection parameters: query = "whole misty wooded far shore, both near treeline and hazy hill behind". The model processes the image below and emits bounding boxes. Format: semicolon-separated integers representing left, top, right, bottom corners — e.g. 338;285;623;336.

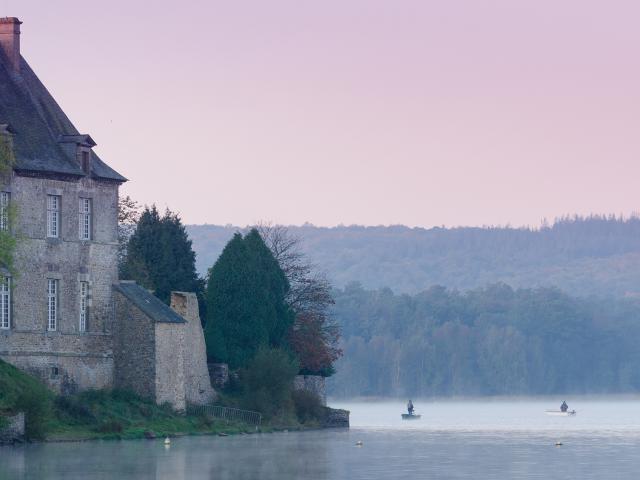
188;216;640;397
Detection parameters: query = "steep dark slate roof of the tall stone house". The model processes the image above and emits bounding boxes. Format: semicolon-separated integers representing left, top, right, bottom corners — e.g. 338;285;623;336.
0;51;127;182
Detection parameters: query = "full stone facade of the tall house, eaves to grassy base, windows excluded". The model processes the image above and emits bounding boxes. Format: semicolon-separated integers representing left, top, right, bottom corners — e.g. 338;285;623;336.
0;175;118;393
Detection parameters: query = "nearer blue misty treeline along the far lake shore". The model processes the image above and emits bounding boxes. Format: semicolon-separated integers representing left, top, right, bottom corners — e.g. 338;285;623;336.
329;284;640;398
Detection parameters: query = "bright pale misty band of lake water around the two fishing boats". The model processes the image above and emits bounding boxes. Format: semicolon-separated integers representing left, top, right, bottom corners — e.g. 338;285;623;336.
331;396;640;438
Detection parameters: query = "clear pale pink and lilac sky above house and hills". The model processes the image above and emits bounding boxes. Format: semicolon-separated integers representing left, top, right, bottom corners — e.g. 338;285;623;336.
5;0;640;227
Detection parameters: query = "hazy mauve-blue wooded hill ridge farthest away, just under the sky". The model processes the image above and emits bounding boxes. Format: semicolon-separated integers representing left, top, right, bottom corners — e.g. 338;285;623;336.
187;215;640;296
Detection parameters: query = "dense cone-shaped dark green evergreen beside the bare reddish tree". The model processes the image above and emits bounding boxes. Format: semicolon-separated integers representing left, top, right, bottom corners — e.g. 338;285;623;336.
205;230;293;368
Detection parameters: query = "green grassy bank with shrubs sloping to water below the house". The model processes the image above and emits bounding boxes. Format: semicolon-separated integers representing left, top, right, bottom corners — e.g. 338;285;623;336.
0;360;320;441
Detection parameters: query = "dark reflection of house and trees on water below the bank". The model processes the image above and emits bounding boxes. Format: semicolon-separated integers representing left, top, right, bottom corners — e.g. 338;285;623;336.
0;432;329;480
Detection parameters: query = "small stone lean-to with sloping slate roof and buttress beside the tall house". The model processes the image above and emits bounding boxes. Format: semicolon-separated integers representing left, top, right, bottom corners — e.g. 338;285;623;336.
114;281;215;410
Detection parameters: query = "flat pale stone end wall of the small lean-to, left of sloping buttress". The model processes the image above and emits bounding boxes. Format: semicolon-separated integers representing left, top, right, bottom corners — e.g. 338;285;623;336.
155;323;187;411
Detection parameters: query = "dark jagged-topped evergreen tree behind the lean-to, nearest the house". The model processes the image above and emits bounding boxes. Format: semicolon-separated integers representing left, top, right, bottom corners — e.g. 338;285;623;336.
121;205;202;304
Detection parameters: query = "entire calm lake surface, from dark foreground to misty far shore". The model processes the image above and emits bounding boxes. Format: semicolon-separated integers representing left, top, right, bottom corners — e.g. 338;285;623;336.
0;398;640;480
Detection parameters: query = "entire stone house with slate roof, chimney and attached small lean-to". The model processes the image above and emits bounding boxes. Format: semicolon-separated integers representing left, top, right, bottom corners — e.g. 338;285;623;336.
0;18;215;410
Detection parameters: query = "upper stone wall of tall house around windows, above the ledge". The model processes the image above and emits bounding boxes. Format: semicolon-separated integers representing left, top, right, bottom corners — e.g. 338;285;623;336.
8;176;118;334
